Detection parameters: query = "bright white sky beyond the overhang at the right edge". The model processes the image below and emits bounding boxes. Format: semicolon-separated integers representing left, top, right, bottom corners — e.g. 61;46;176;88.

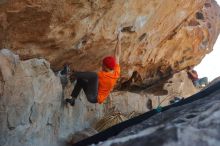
195;0;220;81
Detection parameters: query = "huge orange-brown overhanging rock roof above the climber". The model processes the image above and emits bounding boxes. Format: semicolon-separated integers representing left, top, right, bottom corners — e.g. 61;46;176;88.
0;0;220;85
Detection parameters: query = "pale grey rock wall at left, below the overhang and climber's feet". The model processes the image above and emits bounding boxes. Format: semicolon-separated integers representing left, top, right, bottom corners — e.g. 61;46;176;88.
0;49;103;146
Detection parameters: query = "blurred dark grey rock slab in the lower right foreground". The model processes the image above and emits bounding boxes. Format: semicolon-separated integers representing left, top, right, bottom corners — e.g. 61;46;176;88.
96;82;220;146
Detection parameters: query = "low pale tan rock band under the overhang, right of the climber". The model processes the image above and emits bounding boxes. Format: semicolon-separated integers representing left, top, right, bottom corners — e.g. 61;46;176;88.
105;71;199;115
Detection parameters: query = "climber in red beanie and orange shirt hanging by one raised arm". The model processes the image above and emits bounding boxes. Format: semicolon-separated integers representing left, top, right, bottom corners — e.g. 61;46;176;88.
66;32;122;106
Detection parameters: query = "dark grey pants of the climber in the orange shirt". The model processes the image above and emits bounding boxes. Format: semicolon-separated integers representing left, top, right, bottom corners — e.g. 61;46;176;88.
71;72;98;103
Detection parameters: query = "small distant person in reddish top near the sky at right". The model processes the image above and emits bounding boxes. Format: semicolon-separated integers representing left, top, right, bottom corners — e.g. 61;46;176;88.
187;66;208;88
